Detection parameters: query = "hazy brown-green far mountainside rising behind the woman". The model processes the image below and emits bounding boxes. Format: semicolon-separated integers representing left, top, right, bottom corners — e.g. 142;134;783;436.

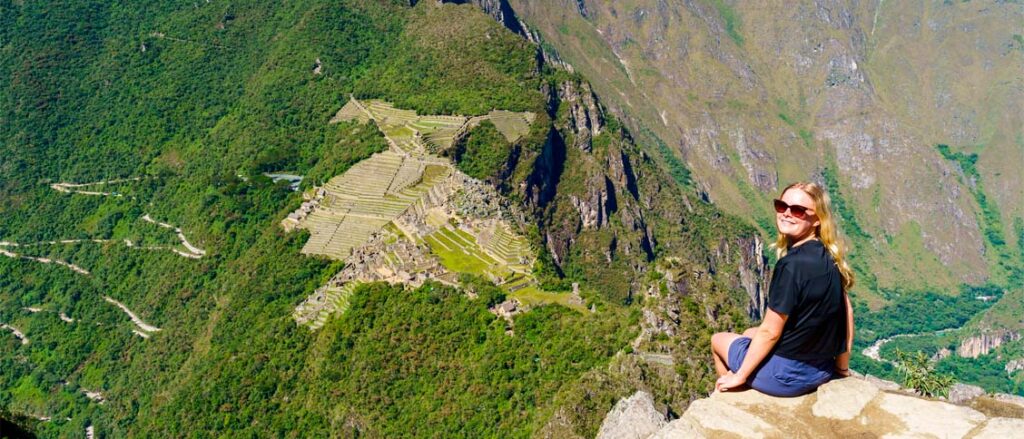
510;0;1024;294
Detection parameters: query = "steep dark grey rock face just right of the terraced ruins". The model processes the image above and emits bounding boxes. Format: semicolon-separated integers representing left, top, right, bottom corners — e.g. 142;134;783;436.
524;76;654;276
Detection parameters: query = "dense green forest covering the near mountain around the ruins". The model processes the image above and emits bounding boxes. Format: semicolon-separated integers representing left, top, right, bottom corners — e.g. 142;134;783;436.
0;0;750;437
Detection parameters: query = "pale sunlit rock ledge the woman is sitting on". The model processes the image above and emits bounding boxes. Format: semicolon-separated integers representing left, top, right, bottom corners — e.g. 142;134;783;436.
598;378;1024;438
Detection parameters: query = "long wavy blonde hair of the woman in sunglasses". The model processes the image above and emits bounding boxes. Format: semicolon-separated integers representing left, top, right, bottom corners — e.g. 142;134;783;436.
772;181;854;292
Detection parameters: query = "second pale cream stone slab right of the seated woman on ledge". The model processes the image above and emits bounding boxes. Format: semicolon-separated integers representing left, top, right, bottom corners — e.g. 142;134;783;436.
878;393;985;438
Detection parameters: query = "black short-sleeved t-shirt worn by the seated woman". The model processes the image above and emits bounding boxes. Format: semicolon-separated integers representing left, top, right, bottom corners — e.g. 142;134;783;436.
768;240;847;360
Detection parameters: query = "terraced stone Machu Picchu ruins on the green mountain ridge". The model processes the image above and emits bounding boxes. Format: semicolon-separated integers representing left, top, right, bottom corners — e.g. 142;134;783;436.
282;97;537;330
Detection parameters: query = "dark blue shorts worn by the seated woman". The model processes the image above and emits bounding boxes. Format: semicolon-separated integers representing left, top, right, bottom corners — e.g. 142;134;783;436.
728;337;836;396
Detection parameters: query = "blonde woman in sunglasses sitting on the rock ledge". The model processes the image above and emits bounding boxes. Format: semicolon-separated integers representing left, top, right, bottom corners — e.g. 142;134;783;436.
711;183;854;396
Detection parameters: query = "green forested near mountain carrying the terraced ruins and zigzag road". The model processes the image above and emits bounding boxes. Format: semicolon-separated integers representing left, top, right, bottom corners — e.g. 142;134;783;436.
0;0;764;437
